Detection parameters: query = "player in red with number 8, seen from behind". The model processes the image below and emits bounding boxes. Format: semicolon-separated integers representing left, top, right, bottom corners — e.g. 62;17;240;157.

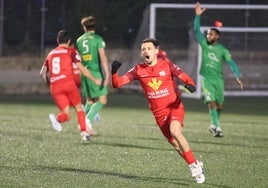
40;30;101;141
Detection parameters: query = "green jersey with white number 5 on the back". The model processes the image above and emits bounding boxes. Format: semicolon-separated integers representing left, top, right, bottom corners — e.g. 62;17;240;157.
76;32;105;74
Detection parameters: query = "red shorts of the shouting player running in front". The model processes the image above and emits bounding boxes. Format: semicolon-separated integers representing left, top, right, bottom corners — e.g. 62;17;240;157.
154;99;184;141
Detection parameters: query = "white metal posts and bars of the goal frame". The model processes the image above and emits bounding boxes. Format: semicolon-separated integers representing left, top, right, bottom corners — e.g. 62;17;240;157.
149;3;268;98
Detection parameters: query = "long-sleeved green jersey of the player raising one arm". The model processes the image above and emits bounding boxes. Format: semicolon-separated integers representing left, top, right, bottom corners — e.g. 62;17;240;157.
194;16;240;80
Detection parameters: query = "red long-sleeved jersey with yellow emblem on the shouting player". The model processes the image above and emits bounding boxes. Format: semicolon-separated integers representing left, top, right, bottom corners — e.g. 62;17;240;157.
112;60;195;112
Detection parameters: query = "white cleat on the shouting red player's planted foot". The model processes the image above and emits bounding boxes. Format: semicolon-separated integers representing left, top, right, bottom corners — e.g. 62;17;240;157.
189;161;205;184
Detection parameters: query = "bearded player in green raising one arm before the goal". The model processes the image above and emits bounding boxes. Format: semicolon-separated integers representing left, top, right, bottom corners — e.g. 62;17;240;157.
194;2;243;137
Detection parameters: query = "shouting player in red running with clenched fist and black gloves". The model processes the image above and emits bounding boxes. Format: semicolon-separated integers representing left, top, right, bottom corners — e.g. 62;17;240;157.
112;38;205;183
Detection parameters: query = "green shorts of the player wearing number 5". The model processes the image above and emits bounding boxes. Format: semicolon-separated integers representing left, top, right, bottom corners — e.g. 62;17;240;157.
81;72;108;98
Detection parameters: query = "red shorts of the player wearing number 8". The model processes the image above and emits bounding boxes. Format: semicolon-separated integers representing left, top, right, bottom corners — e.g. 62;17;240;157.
50;80;82;110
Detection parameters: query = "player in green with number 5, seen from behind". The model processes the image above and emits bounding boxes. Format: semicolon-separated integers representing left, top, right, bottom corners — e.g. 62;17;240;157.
76;16;110;128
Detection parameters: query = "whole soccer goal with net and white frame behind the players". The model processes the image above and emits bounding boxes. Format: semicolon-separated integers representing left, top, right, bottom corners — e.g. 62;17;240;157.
122;4;268;98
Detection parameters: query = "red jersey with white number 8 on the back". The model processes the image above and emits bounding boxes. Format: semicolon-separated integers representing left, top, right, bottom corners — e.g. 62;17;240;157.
44;46;81;84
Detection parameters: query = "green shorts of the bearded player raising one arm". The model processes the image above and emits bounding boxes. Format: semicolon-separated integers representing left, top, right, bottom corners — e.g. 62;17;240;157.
202;77;224;104
